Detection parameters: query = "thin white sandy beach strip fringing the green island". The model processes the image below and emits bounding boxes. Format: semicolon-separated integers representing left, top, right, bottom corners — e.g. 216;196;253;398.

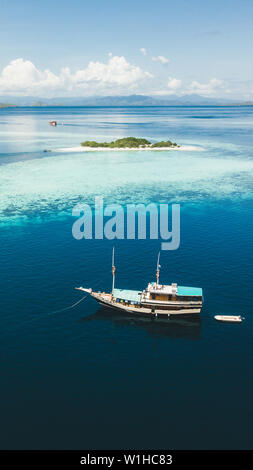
56;145;204;152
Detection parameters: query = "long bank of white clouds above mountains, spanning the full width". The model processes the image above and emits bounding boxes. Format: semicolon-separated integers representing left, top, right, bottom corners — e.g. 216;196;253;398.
0;58;250;100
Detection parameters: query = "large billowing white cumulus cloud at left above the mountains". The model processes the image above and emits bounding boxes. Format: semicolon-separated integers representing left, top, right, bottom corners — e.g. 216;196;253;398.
0;55;152;96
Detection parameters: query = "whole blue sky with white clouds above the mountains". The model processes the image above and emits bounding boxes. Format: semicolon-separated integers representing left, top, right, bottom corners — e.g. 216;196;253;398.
0;0;253;100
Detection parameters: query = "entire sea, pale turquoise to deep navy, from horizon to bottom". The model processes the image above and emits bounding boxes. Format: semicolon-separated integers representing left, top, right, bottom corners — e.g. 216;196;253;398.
0;107;253;449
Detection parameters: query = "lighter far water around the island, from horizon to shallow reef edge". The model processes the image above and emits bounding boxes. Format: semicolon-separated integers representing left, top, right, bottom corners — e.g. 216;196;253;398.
0;107;253;223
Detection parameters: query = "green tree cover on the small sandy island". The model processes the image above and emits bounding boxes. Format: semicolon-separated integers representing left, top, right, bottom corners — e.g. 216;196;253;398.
81;137;180;150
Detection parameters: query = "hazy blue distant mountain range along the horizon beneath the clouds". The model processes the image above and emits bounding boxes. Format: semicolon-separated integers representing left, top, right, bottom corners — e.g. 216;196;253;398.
0;95;253;107
